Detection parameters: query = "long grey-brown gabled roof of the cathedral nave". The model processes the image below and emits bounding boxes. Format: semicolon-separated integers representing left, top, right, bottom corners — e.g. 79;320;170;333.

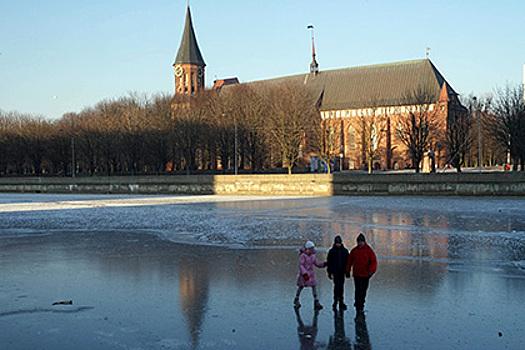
244;59;457;110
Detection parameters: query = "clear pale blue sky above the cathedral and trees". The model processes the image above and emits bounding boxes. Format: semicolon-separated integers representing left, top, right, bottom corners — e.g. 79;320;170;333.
0;0;525;119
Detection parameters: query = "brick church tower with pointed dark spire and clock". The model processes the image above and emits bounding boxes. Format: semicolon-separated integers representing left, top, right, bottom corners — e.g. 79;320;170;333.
173;5;206;94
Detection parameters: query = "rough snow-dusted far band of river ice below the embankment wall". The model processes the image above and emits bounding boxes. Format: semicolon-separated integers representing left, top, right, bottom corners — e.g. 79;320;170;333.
0;194;525;270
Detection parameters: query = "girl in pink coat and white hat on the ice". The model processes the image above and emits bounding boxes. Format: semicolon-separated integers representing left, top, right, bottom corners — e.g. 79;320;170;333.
294;241;325;310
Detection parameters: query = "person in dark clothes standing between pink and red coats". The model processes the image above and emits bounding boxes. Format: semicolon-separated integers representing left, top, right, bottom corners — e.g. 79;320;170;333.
326;236;348;311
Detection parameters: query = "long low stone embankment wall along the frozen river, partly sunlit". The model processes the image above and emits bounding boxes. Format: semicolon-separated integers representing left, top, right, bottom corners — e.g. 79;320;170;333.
0;173;525;196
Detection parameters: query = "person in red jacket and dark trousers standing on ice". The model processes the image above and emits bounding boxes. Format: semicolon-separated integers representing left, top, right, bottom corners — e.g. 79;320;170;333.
346;233;377;313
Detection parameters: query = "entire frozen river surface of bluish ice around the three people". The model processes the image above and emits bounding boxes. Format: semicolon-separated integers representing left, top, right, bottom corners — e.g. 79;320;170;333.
0;194;525;349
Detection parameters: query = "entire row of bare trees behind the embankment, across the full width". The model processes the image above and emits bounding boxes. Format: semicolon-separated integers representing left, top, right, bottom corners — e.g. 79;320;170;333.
0;84;525;176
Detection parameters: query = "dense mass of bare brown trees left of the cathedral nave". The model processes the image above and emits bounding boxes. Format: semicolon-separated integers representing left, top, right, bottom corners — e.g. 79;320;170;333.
0;81;320;176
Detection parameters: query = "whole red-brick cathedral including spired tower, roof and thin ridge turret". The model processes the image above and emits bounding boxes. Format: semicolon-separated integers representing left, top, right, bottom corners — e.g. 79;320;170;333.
173;6;465;170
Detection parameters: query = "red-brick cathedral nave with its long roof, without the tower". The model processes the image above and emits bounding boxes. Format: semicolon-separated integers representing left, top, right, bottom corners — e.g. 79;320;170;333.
249;59;465;170
